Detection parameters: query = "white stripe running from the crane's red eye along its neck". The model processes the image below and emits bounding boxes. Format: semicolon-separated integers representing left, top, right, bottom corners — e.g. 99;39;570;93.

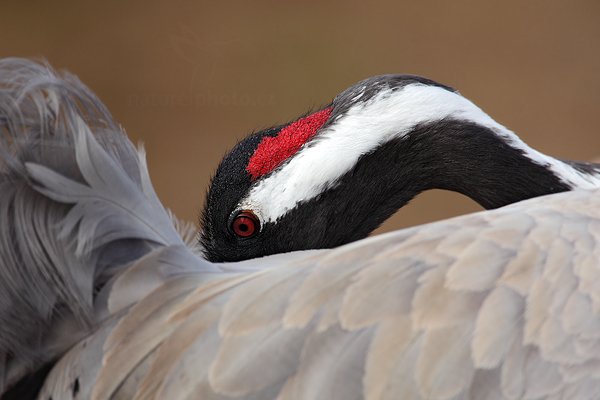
238;83;600;223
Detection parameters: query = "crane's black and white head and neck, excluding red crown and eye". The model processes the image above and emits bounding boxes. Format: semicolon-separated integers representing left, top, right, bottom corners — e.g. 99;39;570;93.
202;75;600;261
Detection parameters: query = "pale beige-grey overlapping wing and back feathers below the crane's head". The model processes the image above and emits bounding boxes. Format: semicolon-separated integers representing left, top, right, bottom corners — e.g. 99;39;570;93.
36;188;600;400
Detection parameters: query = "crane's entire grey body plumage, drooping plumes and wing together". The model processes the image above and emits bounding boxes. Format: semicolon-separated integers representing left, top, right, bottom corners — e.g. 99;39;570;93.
0;60;600;400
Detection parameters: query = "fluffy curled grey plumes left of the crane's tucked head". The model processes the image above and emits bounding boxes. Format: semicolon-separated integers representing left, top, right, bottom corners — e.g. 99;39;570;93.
0;59;213;393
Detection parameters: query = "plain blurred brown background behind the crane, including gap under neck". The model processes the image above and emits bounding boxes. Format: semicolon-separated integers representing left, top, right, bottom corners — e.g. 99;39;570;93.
0;0;600;234
